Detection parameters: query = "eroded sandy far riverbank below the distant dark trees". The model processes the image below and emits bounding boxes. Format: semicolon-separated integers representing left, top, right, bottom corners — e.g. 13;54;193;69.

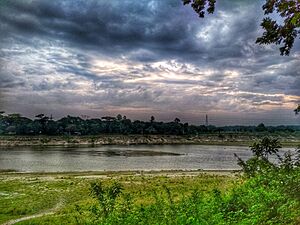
0;132;300;147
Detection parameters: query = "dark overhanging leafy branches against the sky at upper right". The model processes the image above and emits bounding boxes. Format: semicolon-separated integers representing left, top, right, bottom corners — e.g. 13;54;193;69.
182;0;300;55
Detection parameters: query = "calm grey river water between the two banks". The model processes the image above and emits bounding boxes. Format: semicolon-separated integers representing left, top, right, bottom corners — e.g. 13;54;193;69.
0;145;292;172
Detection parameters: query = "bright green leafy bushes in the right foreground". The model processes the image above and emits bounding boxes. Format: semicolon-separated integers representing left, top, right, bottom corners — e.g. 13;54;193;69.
81;138;300;225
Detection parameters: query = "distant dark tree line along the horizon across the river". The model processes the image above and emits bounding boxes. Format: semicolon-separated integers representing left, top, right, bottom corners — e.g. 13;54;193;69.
0;112;300;135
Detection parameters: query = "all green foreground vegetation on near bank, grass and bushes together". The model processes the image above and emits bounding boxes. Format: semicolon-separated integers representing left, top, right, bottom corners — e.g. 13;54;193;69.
0;138;300;225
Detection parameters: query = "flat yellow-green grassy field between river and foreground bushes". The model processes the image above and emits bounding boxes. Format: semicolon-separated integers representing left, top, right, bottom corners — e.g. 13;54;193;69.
0;172;239;224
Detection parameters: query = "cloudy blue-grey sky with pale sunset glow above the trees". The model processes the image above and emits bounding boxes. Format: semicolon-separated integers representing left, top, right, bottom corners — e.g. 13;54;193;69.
0;0;300;126
